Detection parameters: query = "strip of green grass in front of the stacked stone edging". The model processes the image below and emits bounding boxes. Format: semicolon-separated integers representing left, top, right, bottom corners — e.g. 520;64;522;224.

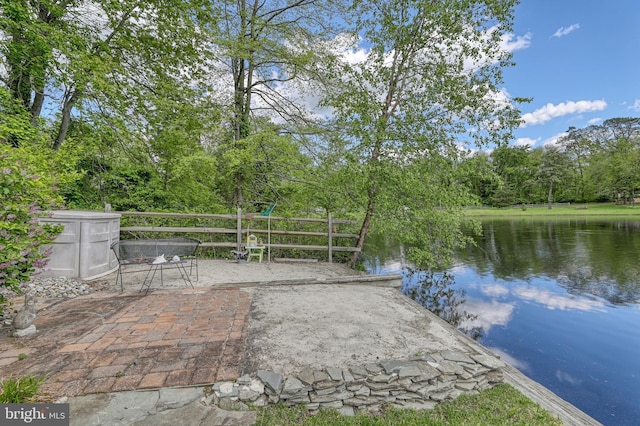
256;384;562;426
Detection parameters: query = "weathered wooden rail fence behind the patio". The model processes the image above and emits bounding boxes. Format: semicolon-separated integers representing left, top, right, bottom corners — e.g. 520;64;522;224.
116;209;359;262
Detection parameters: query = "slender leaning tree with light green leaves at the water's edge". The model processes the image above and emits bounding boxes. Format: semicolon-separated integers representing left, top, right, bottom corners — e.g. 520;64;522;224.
326;0;519;263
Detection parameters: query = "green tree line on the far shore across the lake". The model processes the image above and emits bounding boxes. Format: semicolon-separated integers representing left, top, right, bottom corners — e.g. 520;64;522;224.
460;117;640;207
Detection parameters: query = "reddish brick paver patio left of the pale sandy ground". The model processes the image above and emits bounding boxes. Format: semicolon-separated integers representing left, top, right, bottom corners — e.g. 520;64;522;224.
0;288;251;396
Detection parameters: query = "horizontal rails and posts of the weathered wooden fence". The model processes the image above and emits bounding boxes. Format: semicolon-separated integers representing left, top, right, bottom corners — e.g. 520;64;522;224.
117;209;360;262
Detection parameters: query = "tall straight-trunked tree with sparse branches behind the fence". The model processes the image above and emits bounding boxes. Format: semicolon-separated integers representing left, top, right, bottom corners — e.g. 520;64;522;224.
205;0;339;206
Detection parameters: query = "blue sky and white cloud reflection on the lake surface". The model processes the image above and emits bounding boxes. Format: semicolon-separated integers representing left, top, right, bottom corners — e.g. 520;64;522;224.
376;261;640;425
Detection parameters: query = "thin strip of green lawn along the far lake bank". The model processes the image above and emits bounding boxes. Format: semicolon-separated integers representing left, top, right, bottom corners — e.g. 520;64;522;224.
466;203;640;218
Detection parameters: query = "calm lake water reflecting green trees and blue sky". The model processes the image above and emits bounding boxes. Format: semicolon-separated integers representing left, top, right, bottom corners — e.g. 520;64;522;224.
367;218;640;425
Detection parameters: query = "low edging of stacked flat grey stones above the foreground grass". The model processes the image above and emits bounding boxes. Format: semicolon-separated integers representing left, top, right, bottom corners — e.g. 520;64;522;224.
208;351;506;415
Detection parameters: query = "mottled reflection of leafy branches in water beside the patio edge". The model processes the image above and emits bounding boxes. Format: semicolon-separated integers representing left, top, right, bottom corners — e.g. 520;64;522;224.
403;268;482;339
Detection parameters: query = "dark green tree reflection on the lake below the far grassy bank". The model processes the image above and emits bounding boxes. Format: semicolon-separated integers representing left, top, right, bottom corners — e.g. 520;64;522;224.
458;219;640;304
